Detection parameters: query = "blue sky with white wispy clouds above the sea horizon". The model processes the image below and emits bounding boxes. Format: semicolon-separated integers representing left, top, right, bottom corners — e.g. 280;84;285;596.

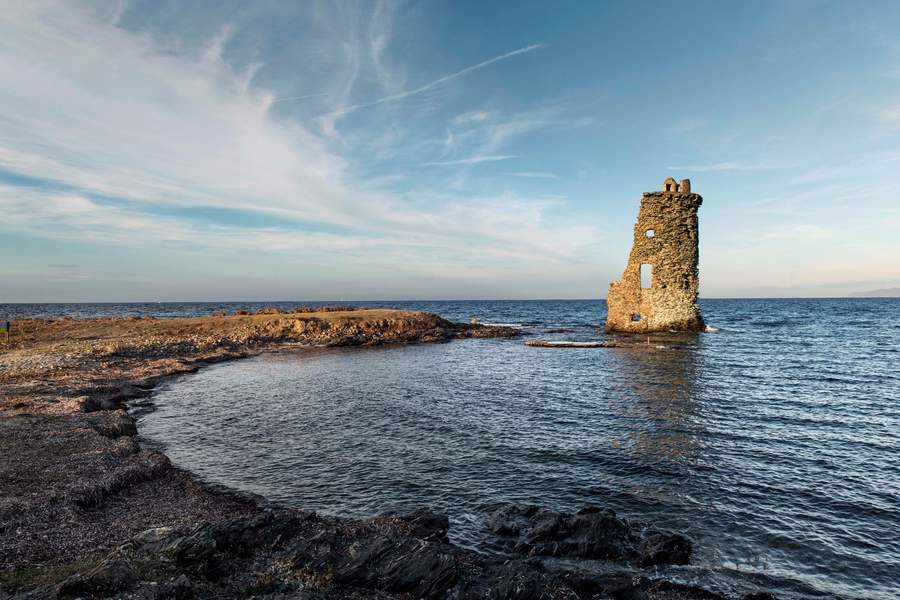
0;0;900;302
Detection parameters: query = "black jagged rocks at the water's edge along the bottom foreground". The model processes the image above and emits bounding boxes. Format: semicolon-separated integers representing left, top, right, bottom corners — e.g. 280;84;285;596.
42;507;769;600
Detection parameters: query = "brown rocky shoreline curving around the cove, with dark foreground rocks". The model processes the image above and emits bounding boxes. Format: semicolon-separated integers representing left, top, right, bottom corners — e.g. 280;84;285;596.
0;309;771;600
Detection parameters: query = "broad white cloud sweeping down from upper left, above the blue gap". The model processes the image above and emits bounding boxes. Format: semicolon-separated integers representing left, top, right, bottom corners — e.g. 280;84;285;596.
0;3;588;256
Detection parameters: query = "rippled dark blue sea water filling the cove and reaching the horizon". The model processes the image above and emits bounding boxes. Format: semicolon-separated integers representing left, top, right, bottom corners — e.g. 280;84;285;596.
0;299;900;599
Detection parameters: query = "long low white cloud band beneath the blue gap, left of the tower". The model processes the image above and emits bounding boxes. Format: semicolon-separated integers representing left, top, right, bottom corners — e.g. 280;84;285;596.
0;185;592;269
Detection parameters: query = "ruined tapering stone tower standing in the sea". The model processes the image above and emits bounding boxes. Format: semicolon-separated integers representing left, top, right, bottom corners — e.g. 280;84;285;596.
606;177;704;333
